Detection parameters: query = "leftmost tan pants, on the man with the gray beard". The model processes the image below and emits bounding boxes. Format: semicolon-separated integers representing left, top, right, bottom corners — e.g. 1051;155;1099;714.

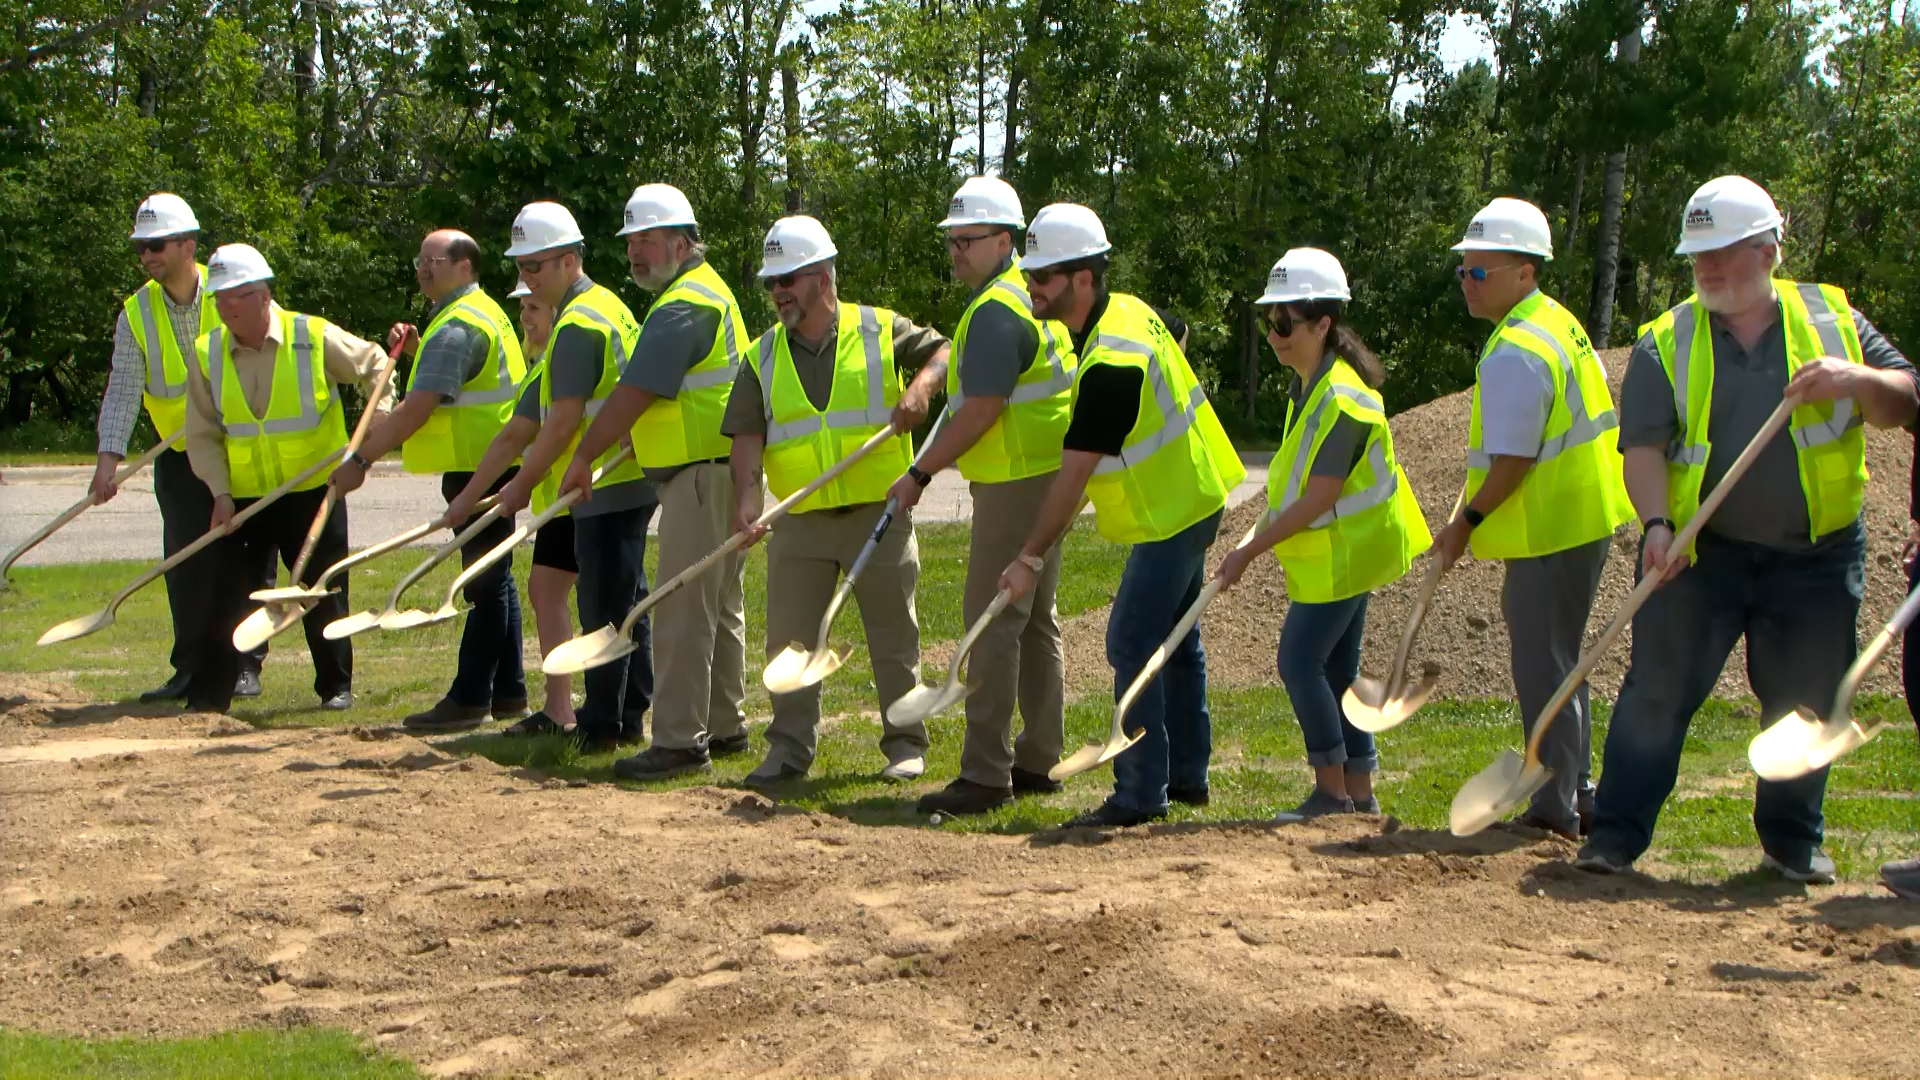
653;465;747;749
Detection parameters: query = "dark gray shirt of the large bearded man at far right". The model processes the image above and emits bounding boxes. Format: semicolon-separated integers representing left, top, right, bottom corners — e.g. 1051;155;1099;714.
1620;297;1920;552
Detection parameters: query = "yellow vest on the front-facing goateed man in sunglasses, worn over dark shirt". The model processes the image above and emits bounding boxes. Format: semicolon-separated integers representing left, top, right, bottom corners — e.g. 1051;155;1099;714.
755;304;914;513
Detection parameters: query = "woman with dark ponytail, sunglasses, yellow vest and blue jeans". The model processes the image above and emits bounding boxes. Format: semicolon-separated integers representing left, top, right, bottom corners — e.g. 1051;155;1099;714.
1215;248;1432;822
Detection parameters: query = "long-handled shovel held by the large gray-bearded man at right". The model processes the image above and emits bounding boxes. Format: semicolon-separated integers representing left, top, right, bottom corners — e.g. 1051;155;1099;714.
1450;398;1799;836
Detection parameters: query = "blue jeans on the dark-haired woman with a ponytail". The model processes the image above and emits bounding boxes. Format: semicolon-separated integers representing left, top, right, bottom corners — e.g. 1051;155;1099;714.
1279;592;1380;773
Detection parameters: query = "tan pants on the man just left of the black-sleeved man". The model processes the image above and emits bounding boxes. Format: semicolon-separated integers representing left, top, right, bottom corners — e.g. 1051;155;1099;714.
960;473;1066;788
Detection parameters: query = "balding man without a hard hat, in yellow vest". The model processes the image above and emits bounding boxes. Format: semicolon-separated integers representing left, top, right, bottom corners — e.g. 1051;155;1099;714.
330;229;526;732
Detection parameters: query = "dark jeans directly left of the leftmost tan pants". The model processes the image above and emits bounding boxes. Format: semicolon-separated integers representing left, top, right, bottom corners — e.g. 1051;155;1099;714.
574;503;659;740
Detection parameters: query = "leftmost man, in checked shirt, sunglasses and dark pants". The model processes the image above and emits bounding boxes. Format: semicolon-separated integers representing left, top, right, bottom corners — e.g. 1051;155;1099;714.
90;192;273;701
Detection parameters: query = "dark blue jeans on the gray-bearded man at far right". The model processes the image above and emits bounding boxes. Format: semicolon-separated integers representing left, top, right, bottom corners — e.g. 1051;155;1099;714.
1590;523;1866;867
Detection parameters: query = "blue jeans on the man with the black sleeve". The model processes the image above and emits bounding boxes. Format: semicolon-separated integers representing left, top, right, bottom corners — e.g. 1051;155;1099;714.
1106;511;1221;813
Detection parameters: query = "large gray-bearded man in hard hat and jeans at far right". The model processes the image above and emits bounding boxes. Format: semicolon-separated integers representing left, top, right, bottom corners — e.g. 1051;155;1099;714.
1574;177;1920;884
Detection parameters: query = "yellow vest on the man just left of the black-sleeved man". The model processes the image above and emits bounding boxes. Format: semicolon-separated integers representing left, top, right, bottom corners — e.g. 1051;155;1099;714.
947;256;1079;484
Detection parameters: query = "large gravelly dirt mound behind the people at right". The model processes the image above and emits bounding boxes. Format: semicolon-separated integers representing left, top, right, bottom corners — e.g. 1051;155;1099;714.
1068;350;1912;700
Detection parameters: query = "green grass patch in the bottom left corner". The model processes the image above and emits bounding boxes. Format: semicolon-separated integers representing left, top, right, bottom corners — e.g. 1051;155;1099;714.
0;1030;419;1080
